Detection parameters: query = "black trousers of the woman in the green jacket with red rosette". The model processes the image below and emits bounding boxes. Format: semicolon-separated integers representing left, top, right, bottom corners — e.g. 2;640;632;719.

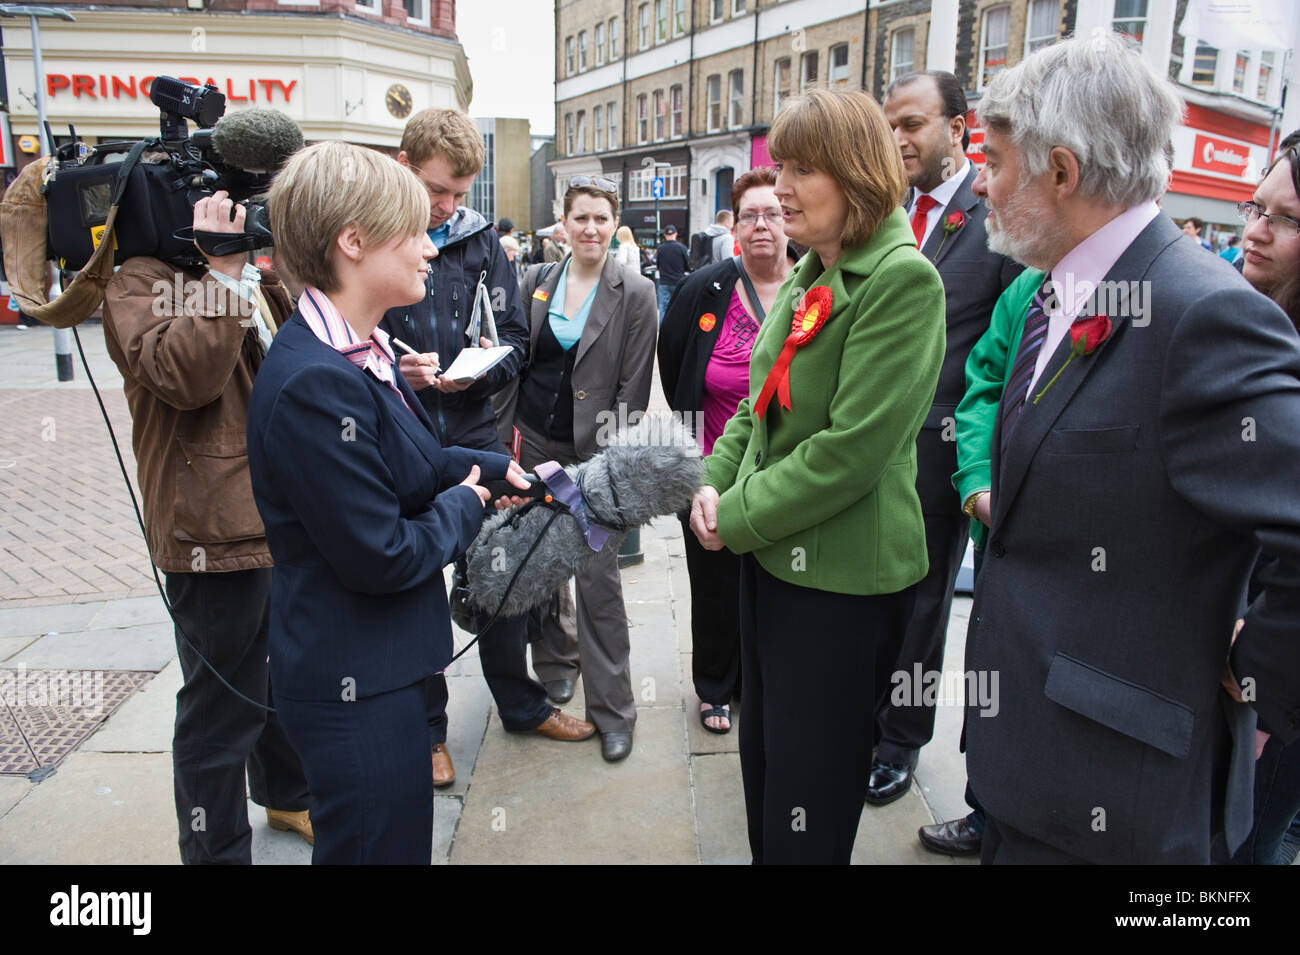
740;555;914;864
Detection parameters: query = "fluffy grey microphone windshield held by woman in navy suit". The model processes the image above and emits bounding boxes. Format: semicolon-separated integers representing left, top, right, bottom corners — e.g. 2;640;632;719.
467;416;705;617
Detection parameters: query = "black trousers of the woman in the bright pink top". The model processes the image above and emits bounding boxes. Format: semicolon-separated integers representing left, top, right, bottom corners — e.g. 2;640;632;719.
677;515;740;704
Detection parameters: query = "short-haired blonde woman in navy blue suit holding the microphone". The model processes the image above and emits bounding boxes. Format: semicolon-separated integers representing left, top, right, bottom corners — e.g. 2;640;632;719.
248;143;525;864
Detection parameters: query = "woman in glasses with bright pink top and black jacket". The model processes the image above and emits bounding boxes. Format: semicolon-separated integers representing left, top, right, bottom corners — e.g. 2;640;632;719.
659;166;794;733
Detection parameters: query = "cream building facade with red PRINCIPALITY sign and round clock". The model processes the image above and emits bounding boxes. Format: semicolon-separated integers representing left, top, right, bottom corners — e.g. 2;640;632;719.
4;0;473;174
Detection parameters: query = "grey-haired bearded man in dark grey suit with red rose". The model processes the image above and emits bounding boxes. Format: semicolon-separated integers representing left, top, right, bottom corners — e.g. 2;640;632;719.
966;32;1300;863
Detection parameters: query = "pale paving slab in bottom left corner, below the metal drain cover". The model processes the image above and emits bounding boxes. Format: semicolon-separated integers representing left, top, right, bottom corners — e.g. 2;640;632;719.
0;752;181;865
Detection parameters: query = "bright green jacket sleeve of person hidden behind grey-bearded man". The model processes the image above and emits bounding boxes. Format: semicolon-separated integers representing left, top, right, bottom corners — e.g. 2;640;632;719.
953;269;1045;550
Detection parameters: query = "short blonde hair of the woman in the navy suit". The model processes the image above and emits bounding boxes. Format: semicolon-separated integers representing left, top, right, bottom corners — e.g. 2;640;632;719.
268;143;429;292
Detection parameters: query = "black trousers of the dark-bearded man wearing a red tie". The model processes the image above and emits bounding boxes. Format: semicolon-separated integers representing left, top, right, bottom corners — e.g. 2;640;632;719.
876;513;970;767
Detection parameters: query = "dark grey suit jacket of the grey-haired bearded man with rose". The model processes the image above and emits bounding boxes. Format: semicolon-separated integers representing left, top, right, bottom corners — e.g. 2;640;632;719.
966;214;1300;863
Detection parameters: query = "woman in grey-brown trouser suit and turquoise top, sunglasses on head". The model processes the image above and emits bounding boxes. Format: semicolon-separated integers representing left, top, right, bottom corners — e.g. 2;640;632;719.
502;175;659;763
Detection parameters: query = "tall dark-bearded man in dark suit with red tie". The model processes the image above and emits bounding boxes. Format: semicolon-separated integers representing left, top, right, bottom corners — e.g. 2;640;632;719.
867;70;1023;806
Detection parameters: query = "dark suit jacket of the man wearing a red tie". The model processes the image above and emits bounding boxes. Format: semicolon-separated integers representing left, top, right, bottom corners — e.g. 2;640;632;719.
906;162;1024;520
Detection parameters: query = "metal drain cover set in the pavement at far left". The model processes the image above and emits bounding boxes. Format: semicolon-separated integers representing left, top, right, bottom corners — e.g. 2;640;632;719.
0;667;153;776
